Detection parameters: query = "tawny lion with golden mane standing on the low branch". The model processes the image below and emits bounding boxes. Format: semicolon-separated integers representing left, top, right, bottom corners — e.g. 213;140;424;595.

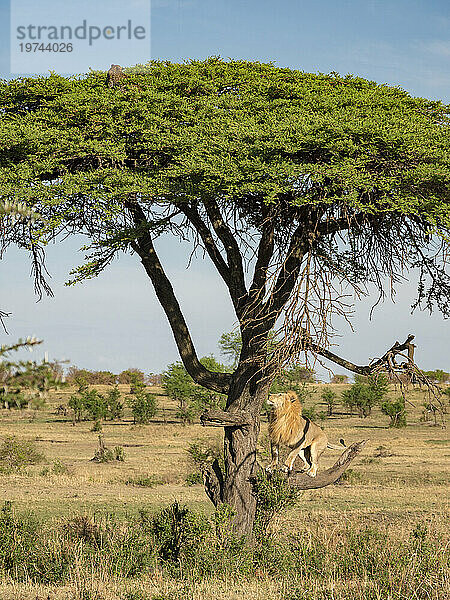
267;390;347;477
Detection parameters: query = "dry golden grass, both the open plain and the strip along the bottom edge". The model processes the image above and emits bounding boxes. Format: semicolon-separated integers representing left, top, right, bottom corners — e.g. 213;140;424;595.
0;385;450;600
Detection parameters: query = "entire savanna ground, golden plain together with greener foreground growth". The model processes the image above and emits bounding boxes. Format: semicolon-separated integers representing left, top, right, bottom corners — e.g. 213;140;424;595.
0;384;450;600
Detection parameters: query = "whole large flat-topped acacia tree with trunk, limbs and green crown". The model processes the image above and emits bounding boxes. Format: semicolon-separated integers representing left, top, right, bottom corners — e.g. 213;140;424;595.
0;58;450;533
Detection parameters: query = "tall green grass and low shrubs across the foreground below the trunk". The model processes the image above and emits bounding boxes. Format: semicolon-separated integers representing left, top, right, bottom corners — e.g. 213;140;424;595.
0;502;448;600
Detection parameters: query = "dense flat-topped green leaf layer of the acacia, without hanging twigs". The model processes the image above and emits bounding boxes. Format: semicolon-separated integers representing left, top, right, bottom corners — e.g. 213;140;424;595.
0;59;449;225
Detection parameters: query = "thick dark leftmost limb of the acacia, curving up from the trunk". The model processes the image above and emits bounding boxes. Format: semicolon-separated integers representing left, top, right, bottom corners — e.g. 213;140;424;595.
126;201;230;394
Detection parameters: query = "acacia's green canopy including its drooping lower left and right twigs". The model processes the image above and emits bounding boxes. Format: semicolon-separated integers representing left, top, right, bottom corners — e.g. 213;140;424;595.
0;58;450;324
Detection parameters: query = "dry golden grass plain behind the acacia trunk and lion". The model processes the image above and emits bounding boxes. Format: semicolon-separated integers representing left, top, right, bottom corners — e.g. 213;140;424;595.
0;385;450;516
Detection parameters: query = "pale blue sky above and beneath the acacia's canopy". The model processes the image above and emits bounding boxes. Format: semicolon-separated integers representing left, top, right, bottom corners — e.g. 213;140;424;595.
0;0;450;372
